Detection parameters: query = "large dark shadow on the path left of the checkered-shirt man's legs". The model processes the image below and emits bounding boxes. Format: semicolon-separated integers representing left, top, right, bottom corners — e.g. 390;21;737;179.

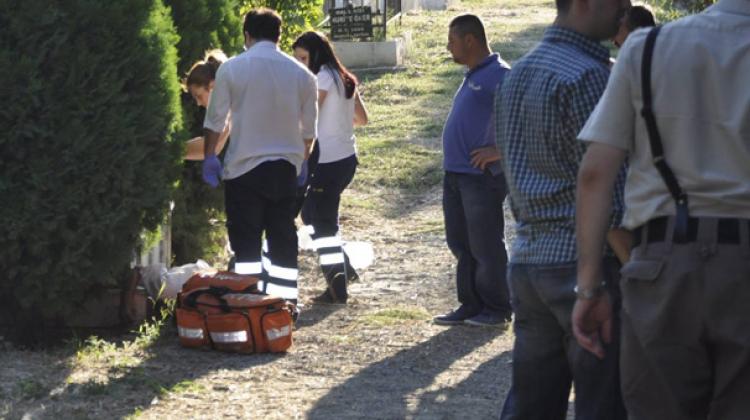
307;327;503;420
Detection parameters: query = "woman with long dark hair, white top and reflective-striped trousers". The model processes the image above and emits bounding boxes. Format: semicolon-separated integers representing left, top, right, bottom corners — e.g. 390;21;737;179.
292;32;367;303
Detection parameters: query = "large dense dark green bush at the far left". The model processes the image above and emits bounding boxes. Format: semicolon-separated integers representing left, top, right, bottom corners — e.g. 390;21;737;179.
0;0;181;326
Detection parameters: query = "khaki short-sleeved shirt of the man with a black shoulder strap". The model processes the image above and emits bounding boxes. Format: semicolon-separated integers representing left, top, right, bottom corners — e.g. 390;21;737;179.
578;0;750;229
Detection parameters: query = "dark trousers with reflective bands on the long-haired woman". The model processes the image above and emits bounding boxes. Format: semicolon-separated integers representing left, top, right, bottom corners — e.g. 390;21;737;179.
302;155;358;283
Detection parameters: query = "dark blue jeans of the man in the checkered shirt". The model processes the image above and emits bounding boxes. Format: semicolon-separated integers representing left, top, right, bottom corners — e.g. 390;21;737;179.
502;258;627;420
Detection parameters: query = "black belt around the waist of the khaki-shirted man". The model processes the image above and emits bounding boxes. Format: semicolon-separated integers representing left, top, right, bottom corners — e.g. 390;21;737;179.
633;217;750;248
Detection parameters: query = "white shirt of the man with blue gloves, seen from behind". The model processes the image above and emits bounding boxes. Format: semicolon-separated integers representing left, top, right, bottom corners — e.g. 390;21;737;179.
203;41;318;179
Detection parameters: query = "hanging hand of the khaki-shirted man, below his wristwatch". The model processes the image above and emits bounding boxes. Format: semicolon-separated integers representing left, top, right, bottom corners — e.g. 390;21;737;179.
572;293;612;359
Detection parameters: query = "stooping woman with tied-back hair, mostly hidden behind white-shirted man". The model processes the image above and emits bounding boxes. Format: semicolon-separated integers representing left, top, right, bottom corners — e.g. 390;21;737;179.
182;49;230;160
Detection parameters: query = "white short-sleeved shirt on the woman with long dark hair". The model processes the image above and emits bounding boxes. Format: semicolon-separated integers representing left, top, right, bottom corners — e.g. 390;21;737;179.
318;65;357;163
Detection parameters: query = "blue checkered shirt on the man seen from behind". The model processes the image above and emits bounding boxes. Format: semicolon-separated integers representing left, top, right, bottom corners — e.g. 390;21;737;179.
495;26;625;264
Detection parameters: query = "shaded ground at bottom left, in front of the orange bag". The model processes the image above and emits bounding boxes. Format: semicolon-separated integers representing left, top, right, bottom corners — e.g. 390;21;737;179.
7;328;278;419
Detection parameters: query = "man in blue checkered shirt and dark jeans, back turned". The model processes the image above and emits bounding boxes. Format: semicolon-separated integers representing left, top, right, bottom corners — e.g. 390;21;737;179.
495;0;630;419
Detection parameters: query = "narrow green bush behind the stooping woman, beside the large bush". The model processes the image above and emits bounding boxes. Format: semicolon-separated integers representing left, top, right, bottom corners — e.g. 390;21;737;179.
165;0;244;265
